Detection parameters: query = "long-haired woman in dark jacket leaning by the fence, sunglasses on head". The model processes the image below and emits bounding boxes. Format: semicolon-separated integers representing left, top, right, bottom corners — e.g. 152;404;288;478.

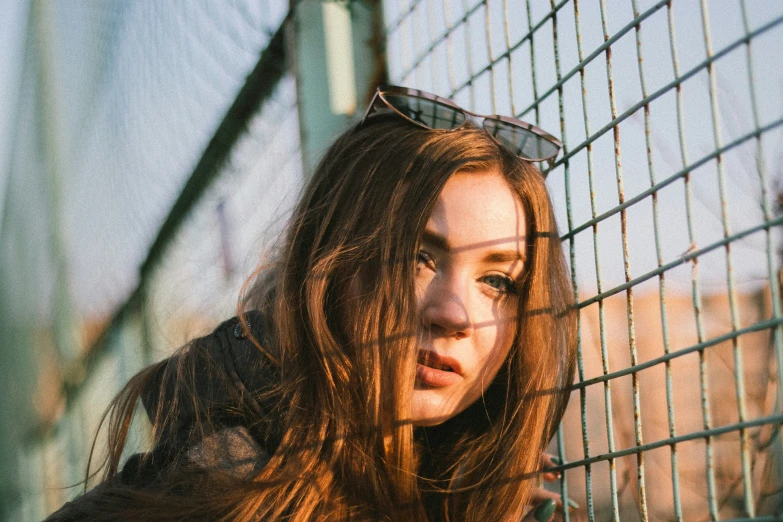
47;87;575;521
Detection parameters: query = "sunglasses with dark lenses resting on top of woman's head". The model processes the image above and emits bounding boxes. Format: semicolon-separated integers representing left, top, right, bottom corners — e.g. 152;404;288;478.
362;85;563;162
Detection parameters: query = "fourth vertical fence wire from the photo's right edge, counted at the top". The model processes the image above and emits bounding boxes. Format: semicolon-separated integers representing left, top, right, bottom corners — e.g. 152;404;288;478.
631;0;682;512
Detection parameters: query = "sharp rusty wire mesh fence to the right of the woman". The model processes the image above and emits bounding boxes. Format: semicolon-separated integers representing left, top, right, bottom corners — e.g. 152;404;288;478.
385;0;783;520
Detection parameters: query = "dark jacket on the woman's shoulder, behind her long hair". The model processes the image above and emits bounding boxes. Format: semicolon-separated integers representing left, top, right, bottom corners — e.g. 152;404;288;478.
46;312;282;522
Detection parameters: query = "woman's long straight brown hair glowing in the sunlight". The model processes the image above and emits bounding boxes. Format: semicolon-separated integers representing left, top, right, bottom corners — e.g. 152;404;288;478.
86;119;575;521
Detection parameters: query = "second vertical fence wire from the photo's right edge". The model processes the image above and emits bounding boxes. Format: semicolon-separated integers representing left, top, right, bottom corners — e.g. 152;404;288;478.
701;0;756;517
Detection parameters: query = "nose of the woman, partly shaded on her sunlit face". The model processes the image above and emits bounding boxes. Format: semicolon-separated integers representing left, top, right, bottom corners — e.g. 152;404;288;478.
421;274;473;339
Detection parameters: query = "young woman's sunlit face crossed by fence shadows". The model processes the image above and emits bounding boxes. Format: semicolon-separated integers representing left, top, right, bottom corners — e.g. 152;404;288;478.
411;171;526;426
